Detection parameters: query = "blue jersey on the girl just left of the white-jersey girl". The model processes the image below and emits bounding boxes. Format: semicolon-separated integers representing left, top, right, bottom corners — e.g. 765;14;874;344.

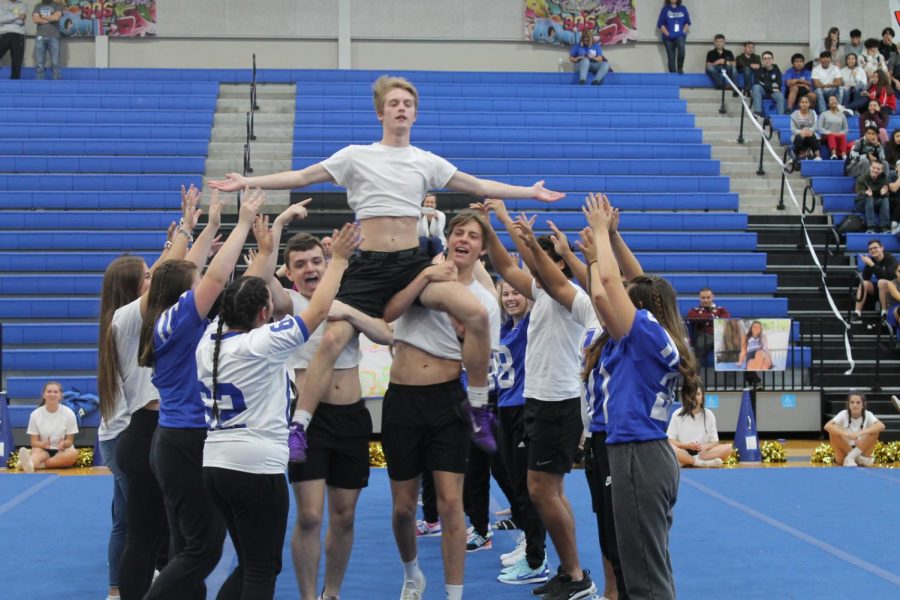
153;290;209;429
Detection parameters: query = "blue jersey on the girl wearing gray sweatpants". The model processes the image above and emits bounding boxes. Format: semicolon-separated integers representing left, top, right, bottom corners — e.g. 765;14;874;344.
591;310;681;444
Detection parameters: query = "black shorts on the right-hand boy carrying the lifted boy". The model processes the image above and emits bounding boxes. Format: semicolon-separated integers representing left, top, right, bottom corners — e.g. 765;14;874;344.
381;379;472;481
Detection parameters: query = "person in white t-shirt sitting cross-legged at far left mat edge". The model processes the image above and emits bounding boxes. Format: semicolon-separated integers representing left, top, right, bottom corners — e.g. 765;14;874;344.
19;381;78;473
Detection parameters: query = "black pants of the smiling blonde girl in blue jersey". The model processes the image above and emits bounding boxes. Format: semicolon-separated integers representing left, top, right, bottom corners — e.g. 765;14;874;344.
498;405;547;569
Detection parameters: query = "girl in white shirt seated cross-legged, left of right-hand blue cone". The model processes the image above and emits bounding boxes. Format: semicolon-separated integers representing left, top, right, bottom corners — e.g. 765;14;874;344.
666;388;732;468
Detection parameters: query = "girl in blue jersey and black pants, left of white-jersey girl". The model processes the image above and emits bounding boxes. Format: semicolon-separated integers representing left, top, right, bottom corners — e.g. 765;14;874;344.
138;190;265;600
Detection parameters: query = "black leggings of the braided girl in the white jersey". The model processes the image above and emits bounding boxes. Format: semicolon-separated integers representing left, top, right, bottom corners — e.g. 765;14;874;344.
203;467;290;600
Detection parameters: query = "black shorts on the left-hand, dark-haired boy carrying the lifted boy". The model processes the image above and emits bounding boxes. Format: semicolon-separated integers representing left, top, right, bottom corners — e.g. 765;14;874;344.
288;400;372;490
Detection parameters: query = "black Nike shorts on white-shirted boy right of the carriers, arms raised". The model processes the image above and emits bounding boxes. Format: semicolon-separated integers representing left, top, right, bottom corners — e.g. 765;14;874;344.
525;398;584;475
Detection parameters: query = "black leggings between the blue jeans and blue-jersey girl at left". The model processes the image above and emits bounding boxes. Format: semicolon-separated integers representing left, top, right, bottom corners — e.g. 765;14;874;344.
116;408;169;600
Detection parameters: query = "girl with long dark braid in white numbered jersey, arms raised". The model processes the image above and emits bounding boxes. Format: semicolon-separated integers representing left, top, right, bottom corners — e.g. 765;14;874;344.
197;218;358;600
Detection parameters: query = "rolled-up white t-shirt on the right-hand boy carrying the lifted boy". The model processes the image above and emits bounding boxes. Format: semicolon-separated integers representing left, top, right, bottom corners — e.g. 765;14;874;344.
394;280;500;361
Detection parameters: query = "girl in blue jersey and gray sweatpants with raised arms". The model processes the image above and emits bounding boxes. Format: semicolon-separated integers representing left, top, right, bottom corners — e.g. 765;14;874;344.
584;195;699;599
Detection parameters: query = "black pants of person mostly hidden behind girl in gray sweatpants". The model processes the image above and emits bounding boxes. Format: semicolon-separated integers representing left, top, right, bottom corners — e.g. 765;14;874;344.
584;431;628;600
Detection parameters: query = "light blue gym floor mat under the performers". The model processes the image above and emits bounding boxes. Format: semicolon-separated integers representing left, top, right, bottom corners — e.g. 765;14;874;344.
0;468;900;600
